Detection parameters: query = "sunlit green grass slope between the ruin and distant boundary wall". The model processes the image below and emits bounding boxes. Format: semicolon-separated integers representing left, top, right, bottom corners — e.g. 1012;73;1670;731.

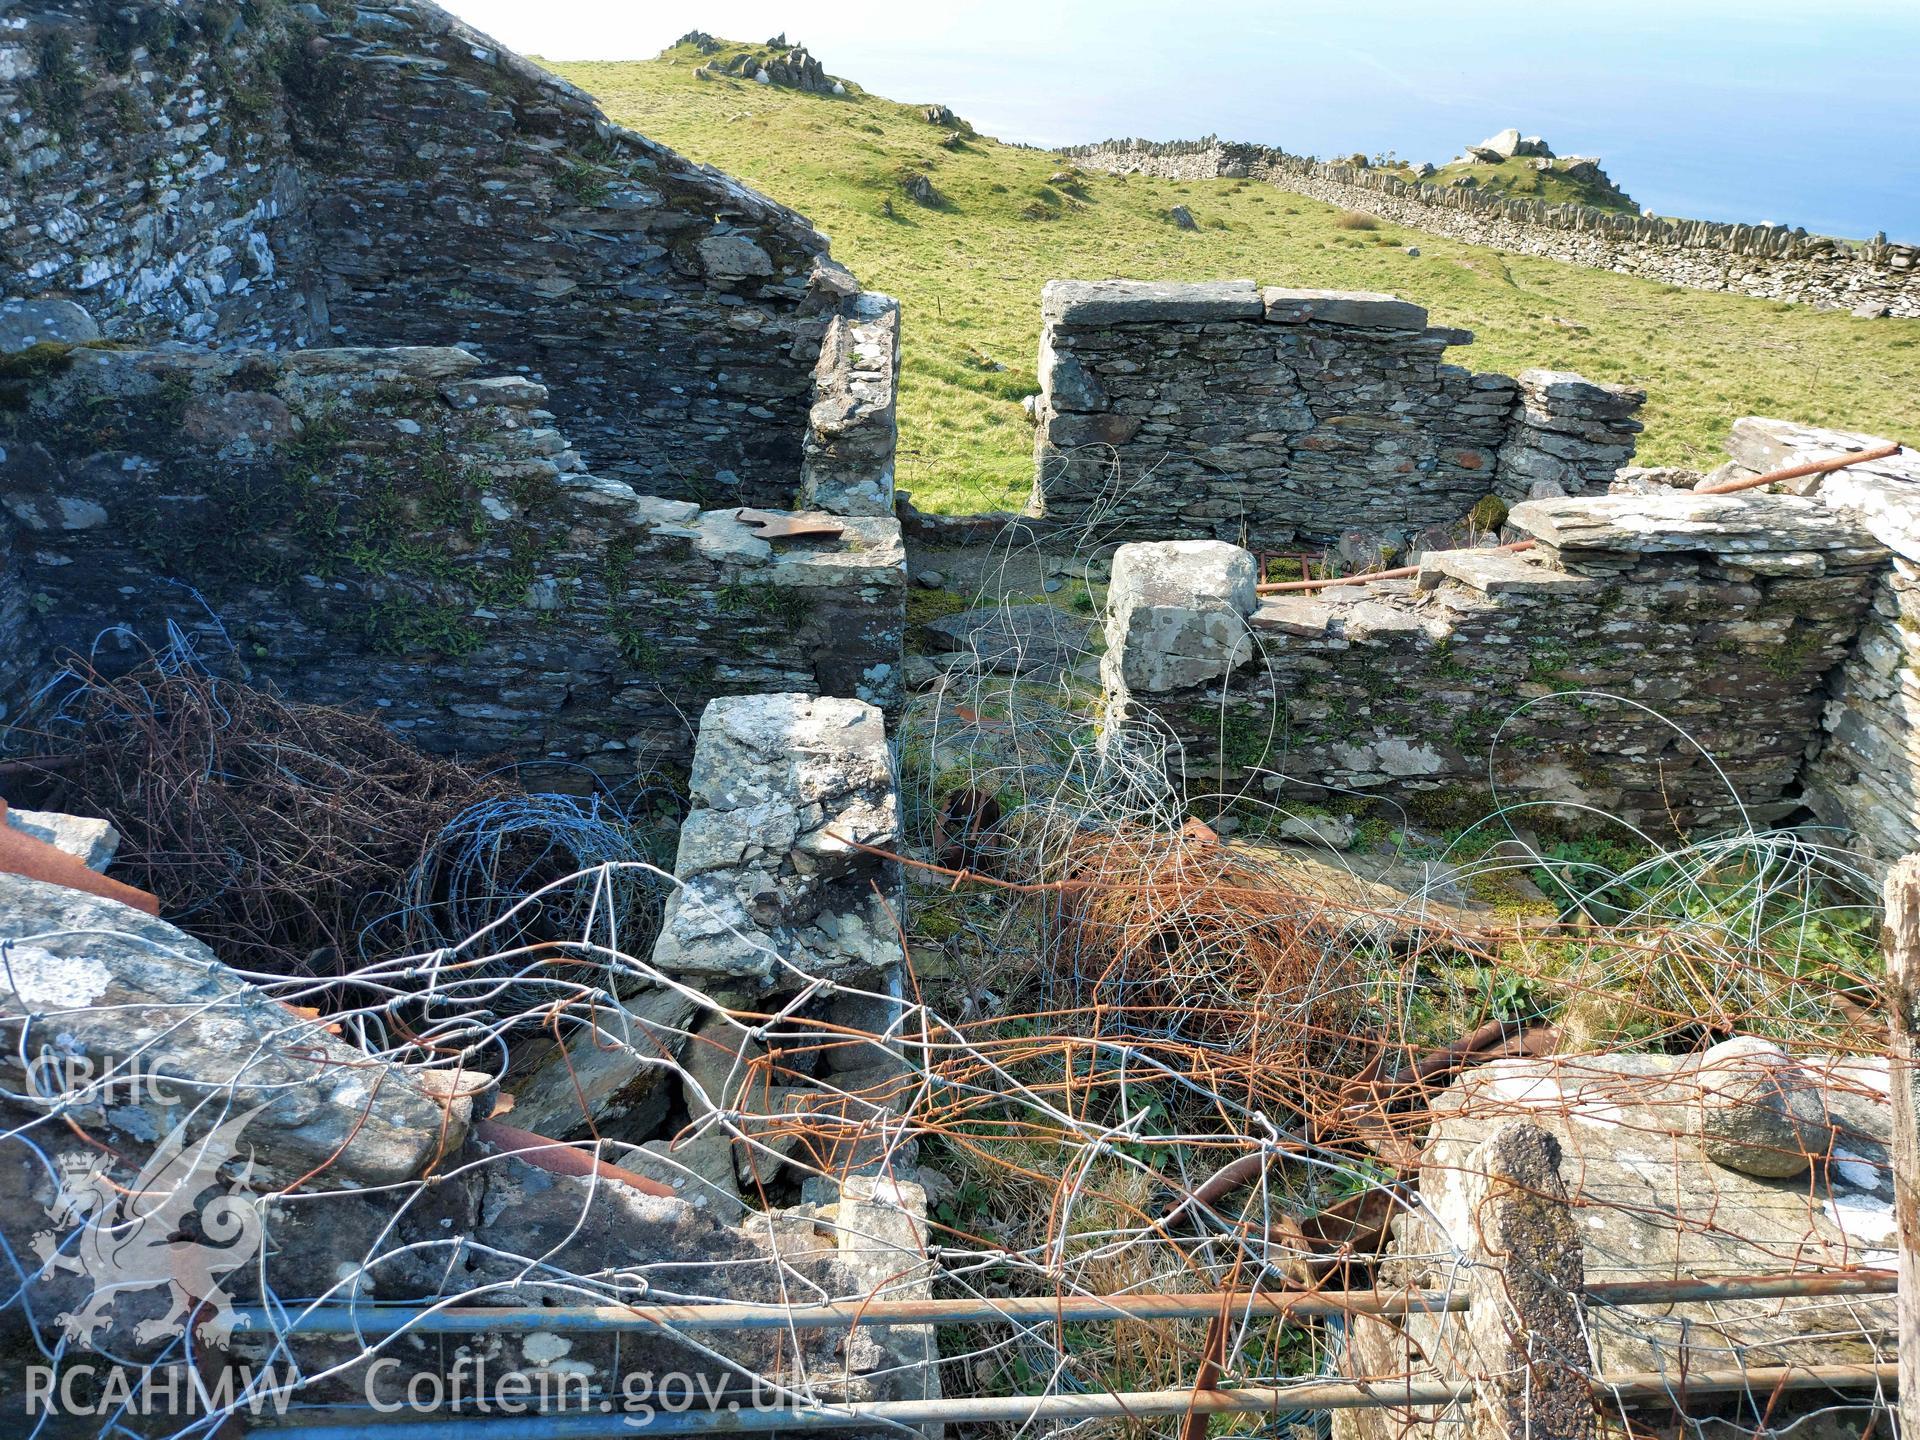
553;46;1920;511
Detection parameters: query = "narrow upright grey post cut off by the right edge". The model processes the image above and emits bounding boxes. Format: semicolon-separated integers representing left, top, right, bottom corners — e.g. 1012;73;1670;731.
1885;854;1920;1436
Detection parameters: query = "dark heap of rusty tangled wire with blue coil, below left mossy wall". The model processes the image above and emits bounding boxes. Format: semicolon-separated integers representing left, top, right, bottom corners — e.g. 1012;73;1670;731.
15;645;676;1002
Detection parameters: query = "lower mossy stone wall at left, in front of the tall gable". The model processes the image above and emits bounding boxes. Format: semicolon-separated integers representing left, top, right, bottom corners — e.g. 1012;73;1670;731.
0;346;904;774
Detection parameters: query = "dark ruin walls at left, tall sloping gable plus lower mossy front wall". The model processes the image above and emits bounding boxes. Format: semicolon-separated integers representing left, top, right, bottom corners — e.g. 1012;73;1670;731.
0;0;904;774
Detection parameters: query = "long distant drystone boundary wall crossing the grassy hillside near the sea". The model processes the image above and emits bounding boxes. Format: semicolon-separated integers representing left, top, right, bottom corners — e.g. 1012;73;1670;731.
1062;140;1920;317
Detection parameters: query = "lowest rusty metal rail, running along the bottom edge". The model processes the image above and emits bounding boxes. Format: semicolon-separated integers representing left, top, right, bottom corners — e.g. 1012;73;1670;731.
253;1365;1899;1440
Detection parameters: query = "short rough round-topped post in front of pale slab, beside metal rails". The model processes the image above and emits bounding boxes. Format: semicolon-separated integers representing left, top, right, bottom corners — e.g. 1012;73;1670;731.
1459;1121;1596;1440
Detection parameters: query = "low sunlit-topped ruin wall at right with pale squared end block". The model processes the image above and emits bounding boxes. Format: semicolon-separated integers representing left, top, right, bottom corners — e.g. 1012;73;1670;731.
1104;420;1920;860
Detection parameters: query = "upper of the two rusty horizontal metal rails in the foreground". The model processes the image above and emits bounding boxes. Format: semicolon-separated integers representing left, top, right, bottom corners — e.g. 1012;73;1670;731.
234;1269;1899;1336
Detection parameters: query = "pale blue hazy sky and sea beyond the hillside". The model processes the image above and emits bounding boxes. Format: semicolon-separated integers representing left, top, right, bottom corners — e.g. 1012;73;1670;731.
447;0;1920;242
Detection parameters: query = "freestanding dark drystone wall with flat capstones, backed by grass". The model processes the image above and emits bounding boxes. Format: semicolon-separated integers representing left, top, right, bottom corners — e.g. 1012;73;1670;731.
1031;280;1645;549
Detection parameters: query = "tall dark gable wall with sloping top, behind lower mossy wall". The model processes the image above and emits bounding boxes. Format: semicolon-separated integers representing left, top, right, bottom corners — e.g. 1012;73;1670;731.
0;0;883;507
